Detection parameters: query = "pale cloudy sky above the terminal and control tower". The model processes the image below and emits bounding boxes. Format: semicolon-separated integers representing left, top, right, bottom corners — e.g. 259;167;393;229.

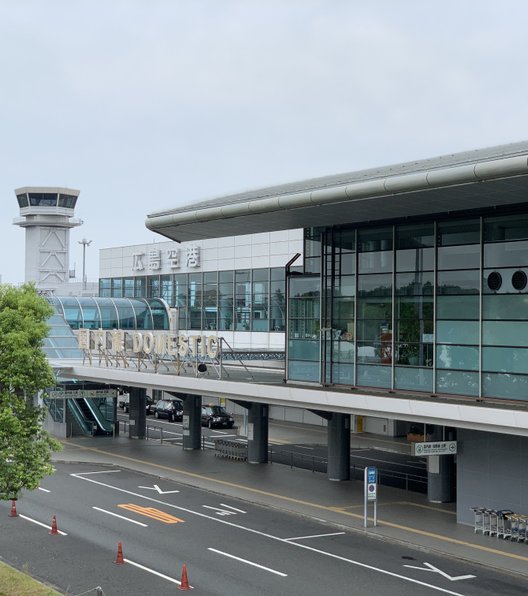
0;0;528;283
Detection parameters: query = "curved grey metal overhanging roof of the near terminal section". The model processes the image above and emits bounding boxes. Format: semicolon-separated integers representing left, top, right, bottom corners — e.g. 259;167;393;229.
145;141;528;242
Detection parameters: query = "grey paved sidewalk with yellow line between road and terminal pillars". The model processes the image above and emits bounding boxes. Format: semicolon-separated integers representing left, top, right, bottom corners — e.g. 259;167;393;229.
54;431;528;577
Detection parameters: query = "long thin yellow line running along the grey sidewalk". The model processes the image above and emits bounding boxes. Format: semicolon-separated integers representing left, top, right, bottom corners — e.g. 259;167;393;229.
62;441;528;562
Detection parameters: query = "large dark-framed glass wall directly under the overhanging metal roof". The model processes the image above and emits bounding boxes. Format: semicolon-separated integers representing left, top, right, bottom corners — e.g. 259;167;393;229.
287;213;528;400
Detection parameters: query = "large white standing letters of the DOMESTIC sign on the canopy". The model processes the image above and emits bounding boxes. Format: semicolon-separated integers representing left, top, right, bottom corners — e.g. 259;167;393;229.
77;329;220;359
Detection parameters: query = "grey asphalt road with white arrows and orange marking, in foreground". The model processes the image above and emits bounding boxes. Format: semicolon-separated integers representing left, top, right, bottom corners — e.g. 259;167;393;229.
0;464;526;596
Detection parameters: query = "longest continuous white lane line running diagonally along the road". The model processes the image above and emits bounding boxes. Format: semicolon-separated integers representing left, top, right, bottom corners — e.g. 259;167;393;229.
70;474;464;596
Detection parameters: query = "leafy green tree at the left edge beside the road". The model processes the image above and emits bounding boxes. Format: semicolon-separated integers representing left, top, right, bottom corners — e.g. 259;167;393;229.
0;284;61;500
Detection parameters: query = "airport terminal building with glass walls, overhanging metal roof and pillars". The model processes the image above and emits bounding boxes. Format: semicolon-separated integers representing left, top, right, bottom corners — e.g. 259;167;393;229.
58;142;528;522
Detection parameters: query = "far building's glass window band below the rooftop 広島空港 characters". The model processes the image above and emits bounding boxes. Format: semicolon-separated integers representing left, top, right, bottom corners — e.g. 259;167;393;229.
99;267;286;333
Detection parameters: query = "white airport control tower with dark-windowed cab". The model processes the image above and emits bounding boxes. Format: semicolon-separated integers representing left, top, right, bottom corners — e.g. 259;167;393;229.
13;186;83;292
